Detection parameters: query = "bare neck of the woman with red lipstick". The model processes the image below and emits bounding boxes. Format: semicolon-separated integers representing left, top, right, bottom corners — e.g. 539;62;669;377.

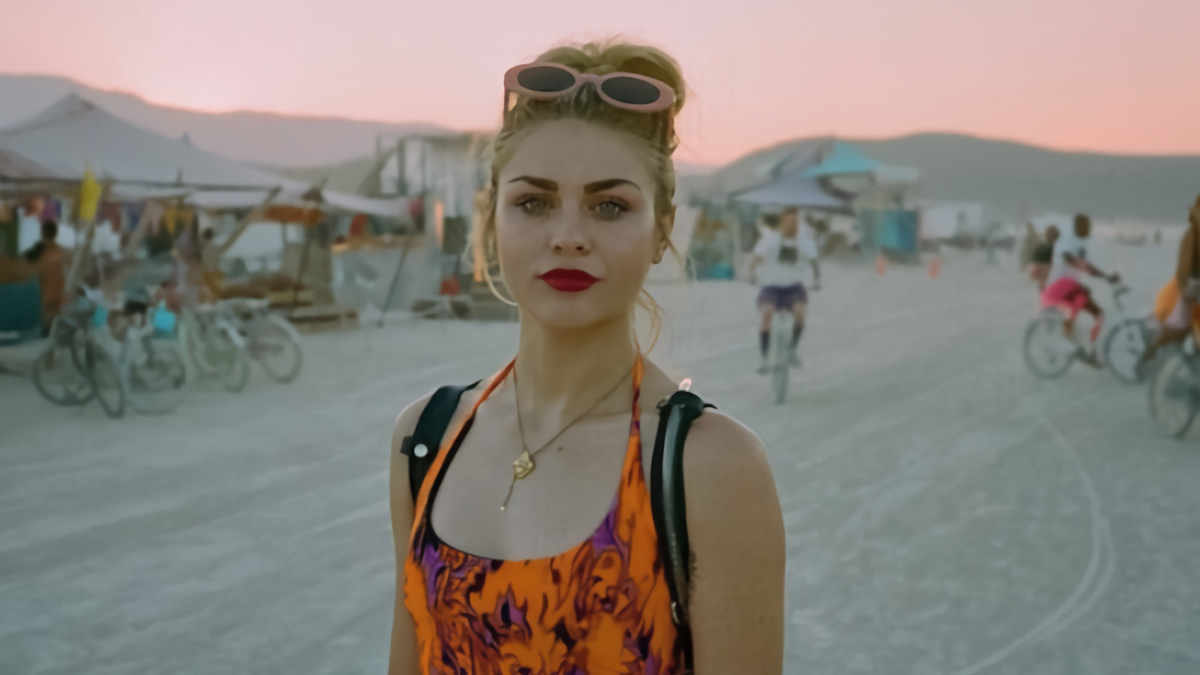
516;316;637;415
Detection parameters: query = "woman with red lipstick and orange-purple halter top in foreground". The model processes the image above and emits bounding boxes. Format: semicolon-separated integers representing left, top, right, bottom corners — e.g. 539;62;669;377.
389;44;785;675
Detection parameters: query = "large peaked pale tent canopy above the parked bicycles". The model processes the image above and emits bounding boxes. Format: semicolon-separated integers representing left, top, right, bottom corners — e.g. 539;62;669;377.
0;94;436;326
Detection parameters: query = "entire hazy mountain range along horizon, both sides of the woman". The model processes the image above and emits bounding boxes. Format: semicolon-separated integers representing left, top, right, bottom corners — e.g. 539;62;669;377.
0;74;1200;223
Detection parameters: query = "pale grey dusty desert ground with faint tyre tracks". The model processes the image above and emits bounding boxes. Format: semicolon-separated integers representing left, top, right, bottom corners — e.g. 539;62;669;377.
0;234;1200;675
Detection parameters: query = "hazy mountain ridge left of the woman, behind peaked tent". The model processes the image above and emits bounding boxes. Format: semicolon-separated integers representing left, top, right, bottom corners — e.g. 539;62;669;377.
0;74;446;166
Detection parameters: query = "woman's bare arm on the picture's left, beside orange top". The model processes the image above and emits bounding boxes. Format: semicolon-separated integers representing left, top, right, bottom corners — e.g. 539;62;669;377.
388;396;428;675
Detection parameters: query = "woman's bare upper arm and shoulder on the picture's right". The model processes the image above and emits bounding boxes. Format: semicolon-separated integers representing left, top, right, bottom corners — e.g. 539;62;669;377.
684;413;786;675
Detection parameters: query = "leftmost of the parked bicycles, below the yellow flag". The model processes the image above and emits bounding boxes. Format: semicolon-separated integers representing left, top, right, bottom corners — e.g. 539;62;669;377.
32;289;125;419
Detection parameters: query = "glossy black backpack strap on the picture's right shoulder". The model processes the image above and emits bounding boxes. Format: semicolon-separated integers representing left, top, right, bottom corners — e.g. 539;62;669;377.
650;389;715;653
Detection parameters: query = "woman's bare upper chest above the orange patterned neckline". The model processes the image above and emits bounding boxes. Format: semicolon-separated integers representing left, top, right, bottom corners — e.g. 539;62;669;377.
430;411;658;560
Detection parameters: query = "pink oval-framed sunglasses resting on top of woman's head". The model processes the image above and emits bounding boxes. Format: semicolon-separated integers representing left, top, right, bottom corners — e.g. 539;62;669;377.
504;64;674;113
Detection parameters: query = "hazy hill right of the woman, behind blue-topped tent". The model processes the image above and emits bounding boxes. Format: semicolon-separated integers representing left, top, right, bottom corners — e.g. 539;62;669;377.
712;133;1200;223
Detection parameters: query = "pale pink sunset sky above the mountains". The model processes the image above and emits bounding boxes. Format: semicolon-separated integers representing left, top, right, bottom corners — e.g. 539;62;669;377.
0;0;1200;163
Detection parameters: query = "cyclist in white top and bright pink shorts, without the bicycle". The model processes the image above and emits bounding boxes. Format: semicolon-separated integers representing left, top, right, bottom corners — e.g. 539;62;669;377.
1042;214;1121;368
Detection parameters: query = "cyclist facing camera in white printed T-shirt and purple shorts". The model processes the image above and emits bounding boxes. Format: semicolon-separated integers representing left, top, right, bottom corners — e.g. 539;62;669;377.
750;207;821;375
